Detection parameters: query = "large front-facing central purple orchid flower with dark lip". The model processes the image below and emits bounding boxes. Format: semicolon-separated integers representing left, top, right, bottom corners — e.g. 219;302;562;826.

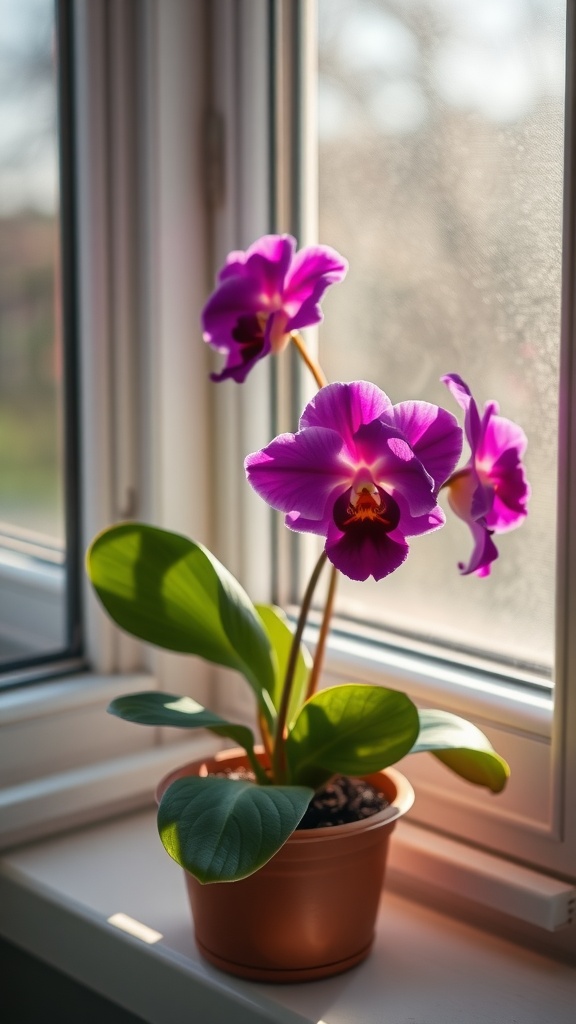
245;381;462;581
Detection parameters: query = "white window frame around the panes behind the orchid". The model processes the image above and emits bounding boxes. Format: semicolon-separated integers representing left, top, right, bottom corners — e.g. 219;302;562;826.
0;0;576;948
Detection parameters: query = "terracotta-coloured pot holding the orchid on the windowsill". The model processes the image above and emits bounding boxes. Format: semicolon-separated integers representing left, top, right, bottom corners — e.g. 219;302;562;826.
158;750;414;982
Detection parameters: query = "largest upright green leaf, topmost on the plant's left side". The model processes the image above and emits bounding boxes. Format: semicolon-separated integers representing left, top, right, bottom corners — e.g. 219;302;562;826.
87;522;276;724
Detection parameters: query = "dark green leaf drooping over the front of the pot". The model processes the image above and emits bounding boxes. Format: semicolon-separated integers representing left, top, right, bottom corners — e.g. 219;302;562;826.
158;775;313;882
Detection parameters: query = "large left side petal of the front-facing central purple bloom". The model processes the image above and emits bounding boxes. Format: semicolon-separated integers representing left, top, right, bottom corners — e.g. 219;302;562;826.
244;427;352;531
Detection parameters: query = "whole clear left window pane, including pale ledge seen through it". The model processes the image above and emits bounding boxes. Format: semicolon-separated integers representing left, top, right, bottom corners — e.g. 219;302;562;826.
0;0;67;667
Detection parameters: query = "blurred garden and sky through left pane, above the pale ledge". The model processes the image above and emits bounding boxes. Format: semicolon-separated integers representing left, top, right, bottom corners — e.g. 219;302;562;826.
0;0;64;542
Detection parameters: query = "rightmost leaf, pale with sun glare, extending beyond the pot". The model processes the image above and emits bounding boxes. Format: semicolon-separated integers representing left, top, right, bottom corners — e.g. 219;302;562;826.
410;709;510;793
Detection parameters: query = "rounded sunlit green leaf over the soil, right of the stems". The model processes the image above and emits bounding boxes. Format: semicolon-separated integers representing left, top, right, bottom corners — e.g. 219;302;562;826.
286;683;418;786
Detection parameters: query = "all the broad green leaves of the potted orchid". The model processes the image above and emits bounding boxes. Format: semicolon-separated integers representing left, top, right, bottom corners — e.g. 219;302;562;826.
87;523;509;882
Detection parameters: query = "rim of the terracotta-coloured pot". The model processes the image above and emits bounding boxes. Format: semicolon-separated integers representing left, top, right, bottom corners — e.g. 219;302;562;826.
155;746;415;843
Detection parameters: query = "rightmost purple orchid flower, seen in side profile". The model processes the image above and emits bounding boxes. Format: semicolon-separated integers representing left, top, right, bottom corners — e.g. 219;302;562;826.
442;374;530;577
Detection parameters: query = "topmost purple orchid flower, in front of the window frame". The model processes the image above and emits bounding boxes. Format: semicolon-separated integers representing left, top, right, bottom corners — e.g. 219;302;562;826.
202;234;347;383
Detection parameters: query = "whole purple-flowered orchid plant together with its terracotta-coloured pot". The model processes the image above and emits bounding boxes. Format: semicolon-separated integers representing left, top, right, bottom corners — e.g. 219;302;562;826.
87;236;529;980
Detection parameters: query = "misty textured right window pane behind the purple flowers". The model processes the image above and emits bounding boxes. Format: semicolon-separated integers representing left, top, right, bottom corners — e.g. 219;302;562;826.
318;0;566;674
